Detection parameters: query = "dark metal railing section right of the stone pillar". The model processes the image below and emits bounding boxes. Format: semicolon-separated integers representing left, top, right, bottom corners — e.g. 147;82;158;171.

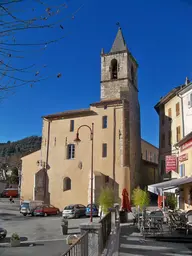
100;212;111;249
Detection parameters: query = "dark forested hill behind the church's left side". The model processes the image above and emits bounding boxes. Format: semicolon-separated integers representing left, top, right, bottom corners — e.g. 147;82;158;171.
0;136;41;167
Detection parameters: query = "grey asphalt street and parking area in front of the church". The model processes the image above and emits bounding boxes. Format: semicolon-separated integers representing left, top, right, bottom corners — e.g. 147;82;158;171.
0;199;98;256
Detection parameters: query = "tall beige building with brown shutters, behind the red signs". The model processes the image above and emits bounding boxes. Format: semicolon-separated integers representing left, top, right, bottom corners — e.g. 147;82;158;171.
155;81;189;179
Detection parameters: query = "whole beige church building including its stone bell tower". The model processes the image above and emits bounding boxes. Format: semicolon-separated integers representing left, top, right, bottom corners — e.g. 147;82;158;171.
21;28;156;209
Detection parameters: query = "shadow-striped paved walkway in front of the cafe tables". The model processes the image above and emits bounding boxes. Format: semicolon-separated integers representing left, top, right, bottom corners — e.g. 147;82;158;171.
119;223;192;256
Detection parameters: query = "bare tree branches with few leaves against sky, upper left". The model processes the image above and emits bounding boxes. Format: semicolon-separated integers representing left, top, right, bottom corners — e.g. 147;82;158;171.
0;0;81;99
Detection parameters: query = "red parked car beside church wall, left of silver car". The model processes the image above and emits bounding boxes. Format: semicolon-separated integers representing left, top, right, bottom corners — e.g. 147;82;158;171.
32;204;60;217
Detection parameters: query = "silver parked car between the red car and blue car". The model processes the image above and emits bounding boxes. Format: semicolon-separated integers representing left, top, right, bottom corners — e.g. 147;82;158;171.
62;204;86;218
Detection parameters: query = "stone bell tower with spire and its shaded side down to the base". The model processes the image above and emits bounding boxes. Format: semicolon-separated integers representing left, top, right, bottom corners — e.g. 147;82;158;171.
100;27;141;191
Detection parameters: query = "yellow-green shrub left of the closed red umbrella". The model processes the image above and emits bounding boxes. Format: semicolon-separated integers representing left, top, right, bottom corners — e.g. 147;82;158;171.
98;187;115;214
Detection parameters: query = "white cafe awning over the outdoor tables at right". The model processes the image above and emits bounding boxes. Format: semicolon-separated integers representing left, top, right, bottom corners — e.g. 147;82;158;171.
148;176;192;195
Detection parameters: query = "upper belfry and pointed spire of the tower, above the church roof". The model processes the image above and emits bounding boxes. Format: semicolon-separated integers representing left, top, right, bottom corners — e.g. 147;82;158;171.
101;28;138;100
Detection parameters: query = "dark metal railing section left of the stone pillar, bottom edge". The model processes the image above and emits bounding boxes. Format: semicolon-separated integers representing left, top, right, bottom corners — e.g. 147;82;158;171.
62;231;89;256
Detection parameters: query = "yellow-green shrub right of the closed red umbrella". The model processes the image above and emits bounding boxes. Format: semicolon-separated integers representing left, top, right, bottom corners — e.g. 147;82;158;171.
132;187;150;210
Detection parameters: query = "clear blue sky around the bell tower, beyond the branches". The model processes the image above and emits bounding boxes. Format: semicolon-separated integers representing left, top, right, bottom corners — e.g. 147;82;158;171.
0;0;192;145
